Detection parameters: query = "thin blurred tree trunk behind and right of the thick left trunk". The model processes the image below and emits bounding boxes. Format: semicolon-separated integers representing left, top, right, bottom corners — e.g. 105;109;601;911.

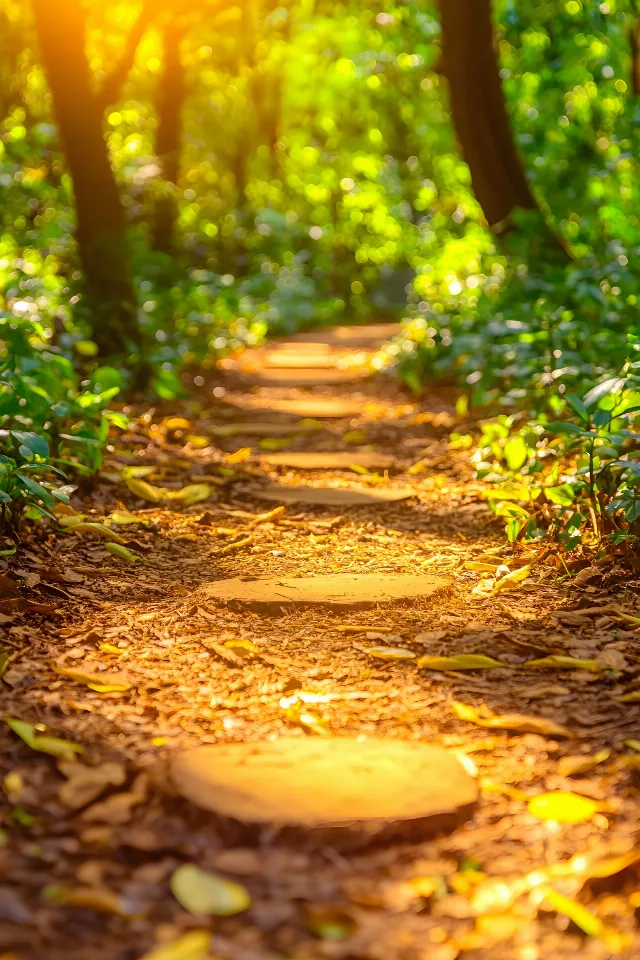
152;23;187;253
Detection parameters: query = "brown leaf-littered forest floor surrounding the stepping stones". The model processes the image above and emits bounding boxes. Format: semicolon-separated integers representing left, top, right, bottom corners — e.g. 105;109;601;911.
0;330;640;960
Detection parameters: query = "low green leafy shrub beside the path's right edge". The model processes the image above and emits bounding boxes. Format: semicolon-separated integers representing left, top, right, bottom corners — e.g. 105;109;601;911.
460;363;640;549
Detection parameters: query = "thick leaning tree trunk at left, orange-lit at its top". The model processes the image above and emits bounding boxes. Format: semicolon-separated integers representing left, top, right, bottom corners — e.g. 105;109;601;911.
33;0;140;356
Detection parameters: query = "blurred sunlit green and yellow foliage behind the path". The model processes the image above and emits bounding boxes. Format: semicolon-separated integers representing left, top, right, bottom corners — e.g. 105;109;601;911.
0;0;640;532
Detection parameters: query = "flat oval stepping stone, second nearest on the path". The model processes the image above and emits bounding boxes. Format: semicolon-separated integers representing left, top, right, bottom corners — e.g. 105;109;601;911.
204;573;449;610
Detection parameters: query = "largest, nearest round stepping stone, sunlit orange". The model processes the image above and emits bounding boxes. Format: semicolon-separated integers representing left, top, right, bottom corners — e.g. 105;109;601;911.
171;737;478;841
